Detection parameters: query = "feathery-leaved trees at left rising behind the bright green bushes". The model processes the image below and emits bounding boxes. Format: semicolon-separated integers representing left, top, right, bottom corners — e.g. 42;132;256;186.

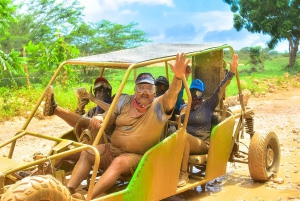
0;0;149;55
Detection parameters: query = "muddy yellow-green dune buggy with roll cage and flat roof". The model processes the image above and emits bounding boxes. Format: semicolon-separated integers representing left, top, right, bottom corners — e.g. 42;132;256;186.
0;44;280;200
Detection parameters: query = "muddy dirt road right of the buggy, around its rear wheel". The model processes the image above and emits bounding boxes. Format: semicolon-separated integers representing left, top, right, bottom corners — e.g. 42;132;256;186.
166;89;300;201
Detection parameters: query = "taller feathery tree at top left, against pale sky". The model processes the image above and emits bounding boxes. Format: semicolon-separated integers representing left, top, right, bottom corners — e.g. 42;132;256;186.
0;0;84;52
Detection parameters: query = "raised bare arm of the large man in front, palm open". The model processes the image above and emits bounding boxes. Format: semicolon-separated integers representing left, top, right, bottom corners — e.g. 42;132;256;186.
162;53;190;114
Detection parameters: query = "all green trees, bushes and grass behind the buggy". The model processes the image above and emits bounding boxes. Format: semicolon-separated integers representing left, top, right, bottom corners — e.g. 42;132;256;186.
0;0;300;121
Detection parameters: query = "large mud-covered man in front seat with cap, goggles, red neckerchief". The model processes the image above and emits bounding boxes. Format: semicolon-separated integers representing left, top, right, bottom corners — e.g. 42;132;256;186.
67;53;189;199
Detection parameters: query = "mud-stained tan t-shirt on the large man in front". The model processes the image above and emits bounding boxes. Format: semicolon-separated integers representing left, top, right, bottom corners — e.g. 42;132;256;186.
103;95;171;154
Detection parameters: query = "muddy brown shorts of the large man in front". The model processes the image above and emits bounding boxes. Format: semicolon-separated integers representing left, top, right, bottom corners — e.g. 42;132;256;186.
97;143;143;176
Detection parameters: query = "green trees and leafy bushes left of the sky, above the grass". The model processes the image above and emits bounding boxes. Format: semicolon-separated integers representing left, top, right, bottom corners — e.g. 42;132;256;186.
0;0;150;88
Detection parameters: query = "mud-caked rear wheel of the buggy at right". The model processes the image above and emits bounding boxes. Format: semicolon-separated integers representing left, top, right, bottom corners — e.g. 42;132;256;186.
248;132;280;181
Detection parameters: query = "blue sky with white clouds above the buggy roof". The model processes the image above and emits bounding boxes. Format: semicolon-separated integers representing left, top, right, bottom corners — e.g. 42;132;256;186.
79;0;288;52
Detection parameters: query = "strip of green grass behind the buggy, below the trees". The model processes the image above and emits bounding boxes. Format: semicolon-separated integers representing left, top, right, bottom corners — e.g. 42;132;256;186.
0;56;300;121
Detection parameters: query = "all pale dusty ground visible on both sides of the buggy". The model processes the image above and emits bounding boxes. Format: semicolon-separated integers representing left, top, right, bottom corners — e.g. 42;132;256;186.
0;89;300;201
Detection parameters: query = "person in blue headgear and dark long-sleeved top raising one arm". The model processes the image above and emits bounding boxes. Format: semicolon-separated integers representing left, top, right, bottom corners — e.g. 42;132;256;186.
177;54;238;187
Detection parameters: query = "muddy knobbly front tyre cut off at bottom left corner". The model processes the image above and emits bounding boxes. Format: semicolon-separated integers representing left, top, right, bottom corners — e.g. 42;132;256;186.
1;175;72;201
